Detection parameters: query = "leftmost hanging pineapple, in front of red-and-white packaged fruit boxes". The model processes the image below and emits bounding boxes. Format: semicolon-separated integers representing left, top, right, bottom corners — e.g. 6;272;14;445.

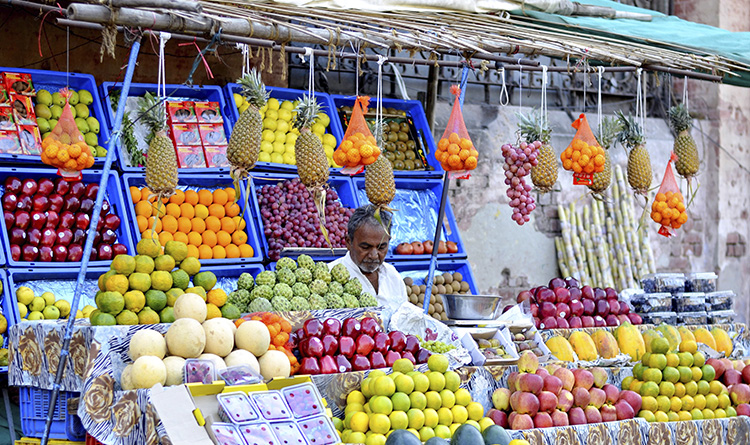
139;93;177;203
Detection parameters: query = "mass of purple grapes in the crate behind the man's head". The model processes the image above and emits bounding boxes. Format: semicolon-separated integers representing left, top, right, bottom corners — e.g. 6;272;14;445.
258;178;354;261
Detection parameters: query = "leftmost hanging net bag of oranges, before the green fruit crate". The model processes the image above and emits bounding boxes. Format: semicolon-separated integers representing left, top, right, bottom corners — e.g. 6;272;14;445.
41;88;94;181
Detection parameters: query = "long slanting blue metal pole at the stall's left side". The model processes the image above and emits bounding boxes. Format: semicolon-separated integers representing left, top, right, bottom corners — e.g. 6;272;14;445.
41;36;141;445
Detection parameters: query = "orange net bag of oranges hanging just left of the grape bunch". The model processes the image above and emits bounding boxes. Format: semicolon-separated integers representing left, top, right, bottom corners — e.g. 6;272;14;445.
435;85;479;179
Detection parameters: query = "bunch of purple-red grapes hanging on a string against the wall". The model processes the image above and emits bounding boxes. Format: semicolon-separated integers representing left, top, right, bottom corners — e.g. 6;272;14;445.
502;141;542;226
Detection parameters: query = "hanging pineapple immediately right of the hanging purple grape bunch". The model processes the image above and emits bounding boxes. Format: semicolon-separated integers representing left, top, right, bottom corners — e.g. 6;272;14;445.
518;110;557;193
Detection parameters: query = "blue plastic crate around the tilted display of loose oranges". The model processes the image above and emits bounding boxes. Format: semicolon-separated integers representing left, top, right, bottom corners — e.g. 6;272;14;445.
123;173;263;266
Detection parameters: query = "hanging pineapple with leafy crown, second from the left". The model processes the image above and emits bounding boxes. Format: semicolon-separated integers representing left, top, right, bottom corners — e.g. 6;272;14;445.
227;69;268;193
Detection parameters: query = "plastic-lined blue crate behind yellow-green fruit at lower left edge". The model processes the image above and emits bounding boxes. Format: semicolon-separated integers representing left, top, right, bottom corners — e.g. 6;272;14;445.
8;267;109;321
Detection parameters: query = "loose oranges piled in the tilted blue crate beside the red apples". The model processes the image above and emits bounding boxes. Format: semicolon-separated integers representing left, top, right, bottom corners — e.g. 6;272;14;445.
130;187;254;260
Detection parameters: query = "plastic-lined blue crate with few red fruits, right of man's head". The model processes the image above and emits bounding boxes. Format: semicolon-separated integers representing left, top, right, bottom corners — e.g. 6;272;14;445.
352;177;467;261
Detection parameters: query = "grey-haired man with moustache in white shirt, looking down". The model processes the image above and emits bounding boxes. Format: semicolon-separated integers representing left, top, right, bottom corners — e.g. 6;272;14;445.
328;204;409;314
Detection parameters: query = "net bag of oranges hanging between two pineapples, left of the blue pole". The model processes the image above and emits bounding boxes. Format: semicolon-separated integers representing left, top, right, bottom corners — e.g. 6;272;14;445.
333;96;380;175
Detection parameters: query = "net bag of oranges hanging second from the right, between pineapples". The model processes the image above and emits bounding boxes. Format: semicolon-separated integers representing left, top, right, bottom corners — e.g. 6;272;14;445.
560;114;607;185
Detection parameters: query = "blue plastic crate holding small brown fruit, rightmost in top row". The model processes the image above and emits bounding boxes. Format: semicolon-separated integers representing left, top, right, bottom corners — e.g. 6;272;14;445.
331;94;443;178
